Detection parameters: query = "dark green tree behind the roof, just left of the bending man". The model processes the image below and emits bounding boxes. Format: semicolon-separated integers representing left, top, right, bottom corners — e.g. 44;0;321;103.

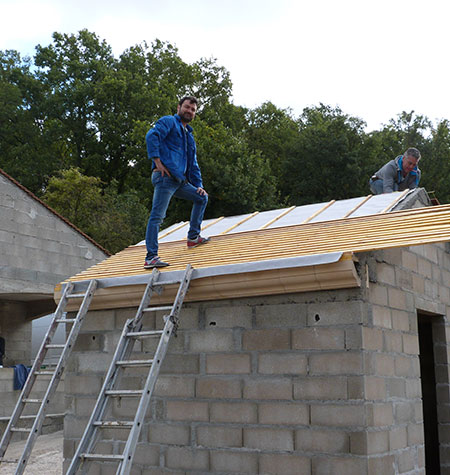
281;104;365;205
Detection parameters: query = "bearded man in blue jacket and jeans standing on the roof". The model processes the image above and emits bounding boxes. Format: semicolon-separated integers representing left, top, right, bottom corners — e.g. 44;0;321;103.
144;96;209;269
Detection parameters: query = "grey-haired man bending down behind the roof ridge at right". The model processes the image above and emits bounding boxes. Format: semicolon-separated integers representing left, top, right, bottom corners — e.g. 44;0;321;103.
369;147;421;195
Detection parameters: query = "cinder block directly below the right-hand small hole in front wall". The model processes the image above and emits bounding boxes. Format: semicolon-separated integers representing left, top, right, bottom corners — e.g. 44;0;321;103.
292;327;345;350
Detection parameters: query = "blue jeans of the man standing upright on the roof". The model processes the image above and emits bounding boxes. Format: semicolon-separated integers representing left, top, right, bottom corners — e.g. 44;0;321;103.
145;171;208;259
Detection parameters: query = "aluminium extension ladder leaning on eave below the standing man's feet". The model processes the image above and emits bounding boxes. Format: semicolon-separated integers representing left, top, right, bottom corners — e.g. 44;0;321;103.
66;265;193;475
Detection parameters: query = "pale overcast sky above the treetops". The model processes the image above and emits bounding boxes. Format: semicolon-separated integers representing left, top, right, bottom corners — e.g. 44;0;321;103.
0;0;450;130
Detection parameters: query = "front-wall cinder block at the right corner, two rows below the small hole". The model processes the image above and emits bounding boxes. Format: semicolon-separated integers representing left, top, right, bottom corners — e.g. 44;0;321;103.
309;351;363;375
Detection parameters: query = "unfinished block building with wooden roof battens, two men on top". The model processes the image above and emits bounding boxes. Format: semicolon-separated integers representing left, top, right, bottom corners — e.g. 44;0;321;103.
55;190;450;475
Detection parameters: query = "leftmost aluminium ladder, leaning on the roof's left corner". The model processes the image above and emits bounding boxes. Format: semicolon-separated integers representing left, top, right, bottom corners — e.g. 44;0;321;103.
0;280;97;475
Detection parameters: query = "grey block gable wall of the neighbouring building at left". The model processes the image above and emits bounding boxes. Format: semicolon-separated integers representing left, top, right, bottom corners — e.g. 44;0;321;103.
0;175;106;294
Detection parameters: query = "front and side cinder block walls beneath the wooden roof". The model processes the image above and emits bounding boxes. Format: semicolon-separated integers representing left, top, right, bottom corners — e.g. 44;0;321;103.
64;245;450;475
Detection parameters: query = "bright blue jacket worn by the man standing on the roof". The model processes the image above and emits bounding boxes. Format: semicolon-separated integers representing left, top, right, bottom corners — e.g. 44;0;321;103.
145;114;203;188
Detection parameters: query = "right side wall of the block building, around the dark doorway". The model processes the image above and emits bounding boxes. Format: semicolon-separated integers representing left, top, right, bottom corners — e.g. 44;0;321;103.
360;243;450;473
